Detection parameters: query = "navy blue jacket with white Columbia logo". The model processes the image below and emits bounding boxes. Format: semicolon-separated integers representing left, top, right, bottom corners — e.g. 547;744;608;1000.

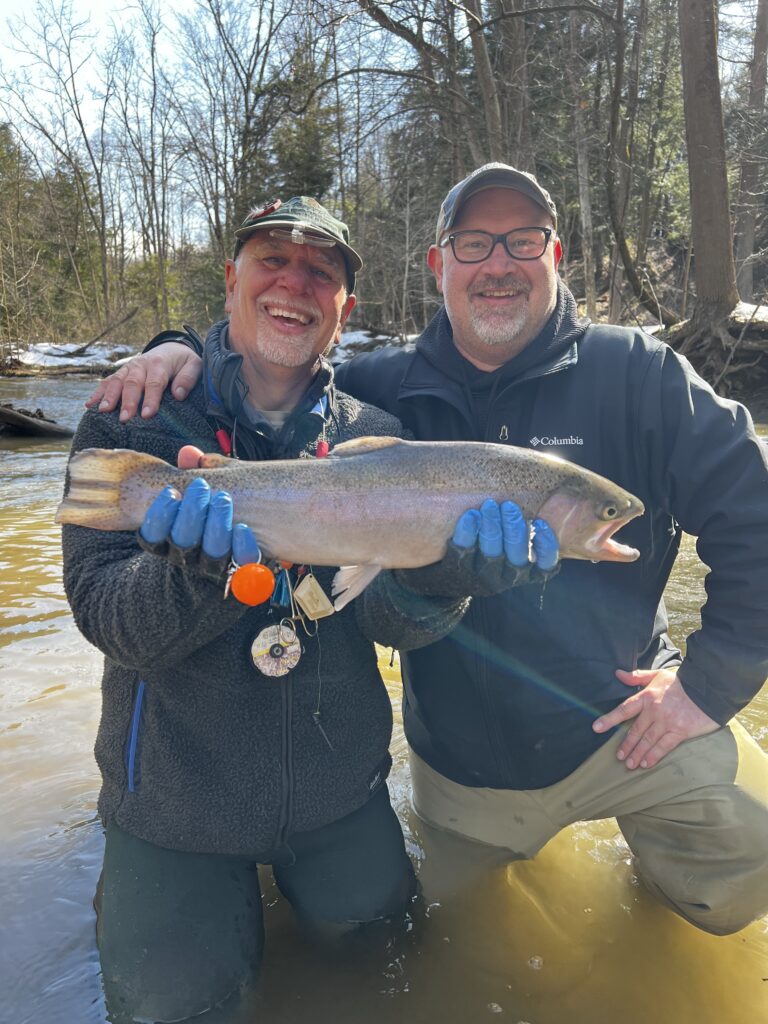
337;286;768;788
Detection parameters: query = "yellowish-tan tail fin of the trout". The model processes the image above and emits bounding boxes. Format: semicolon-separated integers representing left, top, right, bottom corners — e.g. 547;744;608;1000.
55;449;173;529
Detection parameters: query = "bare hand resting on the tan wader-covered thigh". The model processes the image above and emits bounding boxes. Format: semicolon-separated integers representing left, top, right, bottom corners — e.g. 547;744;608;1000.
592;669;720;768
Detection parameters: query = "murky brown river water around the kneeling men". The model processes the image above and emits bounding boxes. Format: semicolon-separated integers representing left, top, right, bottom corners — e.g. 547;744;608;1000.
0;378;768;1024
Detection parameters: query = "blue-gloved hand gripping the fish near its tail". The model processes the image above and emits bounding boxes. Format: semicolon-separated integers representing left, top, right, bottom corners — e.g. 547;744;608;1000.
138;478;261;584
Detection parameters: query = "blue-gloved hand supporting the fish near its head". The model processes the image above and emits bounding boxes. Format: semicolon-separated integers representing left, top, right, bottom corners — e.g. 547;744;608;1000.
394;499;560;597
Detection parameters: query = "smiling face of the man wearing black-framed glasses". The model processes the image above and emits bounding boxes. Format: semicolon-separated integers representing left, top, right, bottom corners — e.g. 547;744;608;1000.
427;188;561;370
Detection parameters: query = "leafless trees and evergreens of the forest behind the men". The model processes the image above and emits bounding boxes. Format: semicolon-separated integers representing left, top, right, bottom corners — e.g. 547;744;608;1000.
0;0;768;392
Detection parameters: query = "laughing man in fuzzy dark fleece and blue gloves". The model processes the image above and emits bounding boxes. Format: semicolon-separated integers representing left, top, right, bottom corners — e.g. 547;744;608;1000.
63;197;481;1024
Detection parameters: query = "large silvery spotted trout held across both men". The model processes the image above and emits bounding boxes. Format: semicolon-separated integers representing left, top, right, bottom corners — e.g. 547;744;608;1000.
56;437;644;607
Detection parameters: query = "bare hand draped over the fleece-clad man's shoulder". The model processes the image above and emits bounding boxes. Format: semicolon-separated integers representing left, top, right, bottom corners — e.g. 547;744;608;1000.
85;342;203;423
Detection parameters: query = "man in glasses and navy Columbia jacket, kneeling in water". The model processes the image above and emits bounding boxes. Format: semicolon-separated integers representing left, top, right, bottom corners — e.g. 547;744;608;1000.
87;163;768;934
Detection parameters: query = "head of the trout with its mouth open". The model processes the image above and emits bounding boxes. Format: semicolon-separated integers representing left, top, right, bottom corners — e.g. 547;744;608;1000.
537;473;645;562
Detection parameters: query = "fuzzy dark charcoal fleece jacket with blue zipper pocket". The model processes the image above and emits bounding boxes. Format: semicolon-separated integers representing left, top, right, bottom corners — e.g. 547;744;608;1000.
62;325;466;861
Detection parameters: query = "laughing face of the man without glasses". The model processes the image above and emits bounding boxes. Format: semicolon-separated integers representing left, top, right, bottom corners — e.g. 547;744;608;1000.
225;230;354;371
